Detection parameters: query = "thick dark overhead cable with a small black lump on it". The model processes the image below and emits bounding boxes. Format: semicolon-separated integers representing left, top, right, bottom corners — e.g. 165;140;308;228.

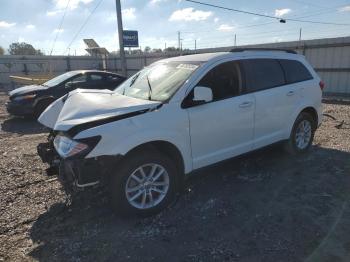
185;0;350;26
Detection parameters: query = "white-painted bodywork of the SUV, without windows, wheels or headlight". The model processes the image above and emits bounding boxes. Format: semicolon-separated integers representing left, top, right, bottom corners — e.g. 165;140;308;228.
39;51;322;173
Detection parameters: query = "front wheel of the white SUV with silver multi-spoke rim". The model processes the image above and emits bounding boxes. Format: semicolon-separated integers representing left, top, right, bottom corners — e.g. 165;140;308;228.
110;149;179;216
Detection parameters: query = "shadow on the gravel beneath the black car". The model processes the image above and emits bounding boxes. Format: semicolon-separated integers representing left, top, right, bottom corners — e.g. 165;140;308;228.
0;117;48;135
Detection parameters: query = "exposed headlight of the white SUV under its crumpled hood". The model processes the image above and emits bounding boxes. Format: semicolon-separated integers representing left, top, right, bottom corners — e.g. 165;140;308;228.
53;134;101;158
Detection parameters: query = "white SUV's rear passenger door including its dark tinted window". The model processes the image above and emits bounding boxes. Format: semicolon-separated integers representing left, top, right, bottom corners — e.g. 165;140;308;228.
243;58;298;149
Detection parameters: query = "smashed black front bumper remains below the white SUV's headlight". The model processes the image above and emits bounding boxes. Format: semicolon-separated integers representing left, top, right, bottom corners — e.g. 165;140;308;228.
37;138;121;192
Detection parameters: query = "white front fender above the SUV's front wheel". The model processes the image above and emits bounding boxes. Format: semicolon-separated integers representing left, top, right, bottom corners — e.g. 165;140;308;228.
74;104;192;173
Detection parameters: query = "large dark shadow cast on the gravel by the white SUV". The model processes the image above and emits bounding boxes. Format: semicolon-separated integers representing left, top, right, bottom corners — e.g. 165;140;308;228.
29;146;350;261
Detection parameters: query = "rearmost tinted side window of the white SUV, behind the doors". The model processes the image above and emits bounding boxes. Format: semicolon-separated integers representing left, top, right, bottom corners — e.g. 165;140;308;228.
279;59;313;84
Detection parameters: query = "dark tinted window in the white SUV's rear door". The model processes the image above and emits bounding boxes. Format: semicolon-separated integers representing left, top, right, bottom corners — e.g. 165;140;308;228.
242;59;285;93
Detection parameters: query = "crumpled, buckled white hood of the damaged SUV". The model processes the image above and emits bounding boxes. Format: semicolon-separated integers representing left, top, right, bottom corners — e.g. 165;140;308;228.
38;89;160;131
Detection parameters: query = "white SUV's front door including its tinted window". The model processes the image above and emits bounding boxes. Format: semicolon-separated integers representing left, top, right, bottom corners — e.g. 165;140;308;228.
186;62;255;169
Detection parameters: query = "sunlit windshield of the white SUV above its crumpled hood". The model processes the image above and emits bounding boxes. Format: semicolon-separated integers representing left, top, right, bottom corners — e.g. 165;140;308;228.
115;62;199;102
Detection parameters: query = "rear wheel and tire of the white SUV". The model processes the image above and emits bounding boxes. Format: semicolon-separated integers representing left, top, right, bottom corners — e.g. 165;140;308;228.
285;112;316;155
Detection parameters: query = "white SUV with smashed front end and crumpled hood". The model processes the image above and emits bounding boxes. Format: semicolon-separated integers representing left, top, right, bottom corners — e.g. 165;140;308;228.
38;50;323;214
